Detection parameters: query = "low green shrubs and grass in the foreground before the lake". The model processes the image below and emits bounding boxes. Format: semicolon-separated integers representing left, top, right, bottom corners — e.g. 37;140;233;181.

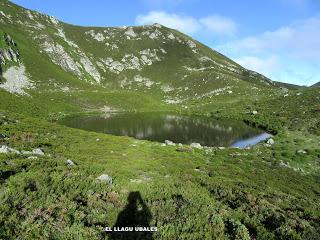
0;90;320;239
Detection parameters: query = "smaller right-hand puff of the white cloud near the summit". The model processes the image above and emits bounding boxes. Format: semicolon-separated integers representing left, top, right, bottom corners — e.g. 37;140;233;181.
200;15;237;35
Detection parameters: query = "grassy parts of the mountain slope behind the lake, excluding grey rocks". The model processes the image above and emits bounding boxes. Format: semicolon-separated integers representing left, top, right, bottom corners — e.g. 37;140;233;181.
0;0;277;118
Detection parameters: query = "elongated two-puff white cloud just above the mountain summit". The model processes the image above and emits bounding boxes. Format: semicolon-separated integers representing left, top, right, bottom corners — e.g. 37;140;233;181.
136;11;237;36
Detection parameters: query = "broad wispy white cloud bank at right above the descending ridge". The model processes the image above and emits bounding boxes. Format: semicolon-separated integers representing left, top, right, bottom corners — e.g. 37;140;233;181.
216;16;320;85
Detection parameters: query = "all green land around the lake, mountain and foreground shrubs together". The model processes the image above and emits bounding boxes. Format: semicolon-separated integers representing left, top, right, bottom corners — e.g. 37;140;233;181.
0;0;320;240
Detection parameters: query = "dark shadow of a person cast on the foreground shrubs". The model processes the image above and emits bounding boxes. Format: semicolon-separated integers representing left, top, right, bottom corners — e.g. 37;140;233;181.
110;192;152;240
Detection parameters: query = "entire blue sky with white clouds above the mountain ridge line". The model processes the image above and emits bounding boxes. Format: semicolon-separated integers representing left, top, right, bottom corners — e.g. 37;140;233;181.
13;0;320;85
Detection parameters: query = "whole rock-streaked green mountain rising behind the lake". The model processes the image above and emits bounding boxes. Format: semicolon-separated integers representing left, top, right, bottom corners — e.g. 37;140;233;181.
0;0;277;114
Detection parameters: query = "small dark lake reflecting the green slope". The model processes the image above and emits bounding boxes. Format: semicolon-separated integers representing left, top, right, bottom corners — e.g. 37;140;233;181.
61;112;271;148
